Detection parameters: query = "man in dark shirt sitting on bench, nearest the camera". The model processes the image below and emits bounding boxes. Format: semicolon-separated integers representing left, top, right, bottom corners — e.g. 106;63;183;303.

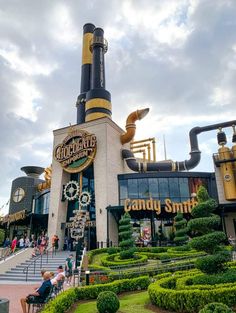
20;272;52;313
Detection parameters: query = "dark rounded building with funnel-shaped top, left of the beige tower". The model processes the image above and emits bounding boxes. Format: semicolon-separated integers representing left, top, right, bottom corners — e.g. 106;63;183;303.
3;166;50;239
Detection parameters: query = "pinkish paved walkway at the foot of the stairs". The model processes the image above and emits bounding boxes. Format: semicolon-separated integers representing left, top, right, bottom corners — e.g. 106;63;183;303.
0;284;39;313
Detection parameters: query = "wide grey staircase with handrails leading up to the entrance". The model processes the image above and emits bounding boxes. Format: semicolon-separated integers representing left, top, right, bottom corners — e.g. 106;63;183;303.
0;251;72;283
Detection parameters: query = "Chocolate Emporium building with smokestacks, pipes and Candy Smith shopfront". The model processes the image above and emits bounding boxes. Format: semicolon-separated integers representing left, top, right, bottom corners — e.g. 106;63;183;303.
3;24;236;249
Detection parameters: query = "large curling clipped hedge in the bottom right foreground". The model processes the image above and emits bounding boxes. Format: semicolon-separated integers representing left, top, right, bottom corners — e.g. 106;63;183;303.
148;270;236;313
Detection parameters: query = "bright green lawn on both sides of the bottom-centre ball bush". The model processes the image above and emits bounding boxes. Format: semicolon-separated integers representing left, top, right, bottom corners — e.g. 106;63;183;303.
74;291;153;313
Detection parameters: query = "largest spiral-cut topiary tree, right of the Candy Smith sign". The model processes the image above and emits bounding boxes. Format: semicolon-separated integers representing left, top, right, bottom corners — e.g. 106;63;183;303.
188;186;230;274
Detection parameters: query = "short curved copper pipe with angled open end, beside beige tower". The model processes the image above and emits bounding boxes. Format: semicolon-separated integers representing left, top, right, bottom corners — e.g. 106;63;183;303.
120;108;149;145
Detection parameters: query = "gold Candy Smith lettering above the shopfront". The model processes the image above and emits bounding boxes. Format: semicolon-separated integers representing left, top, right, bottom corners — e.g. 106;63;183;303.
124;198;197;215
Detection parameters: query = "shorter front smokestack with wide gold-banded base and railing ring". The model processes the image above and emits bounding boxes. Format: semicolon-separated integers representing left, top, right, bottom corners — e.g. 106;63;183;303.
85;28;111;122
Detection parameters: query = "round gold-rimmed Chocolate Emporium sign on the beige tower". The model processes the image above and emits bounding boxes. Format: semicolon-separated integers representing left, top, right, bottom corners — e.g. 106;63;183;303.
53;129;97;173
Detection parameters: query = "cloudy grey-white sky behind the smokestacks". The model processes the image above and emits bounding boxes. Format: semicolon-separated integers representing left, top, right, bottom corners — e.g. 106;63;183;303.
0;0;236;210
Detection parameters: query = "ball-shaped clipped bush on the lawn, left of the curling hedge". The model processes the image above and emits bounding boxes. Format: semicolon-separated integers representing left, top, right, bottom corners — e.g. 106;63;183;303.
97;291;120;313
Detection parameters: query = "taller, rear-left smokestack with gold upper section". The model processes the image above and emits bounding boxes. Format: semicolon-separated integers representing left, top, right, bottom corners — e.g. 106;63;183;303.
76;23;95;124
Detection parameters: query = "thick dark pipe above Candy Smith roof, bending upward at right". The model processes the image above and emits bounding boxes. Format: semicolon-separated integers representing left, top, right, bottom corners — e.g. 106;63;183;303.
122;120;236;172
